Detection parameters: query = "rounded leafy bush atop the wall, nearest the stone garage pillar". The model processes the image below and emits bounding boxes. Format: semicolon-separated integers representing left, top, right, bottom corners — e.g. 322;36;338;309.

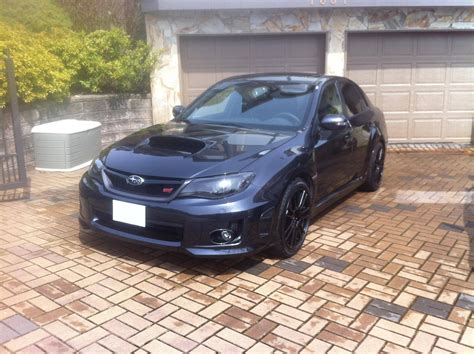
44;29;156;93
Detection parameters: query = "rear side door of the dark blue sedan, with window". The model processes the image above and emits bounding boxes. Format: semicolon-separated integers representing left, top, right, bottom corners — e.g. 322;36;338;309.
340;80;374;178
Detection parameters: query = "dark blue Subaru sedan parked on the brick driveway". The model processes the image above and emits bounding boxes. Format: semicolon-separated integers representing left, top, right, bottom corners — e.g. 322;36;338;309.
80;73;387;257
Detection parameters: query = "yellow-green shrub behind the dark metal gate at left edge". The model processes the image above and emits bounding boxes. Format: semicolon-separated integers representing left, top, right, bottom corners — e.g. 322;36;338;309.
0;22;73;106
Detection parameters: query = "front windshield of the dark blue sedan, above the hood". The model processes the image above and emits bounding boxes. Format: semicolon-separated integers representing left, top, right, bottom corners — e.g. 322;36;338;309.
179;81;314;130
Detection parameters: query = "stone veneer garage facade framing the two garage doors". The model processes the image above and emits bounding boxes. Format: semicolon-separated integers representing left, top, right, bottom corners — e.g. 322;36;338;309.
146;7;474;121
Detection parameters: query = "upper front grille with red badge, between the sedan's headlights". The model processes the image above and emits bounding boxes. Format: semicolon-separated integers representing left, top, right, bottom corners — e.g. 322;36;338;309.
104;169;183;198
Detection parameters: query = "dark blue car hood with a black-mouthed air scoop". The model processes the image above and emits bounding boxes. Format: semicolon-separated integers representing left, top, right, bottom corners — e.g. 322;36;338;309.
102;122;295;179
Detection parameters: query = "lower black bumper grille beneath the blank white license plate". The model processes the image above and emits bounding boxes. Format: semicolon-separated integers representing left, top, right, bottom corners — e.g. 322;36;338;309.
94;210;183;242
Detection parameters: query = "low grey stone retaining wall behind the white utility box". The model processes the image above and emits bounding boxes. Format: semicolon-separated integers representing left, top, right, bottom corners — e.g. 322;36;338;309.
0;95;153;166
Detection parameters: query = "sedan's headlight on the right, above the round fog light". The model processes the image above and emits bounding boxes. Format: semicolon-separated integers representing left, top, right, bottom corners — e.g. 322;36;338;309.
179;173;255;199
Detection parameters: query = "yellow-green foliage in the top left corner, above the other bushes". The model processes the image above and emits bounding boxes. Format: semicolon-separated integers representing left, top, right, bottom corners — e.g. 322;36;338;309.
0;0;72;32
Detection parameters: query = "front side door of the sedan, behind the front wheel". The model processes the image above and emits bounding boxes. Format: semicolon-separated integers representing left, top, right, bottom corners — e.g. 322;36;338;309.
313;80;353;200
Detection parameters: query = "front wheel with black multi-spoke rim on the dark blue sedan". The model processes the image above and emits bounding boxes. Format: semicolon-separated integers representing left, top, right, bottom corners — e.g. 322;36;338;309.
272;178;311;258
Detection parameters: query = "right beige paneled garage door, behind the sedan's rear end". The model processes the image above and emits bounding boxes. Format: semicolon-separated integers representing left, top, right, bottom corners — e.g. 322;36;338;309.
347;32;474;142
